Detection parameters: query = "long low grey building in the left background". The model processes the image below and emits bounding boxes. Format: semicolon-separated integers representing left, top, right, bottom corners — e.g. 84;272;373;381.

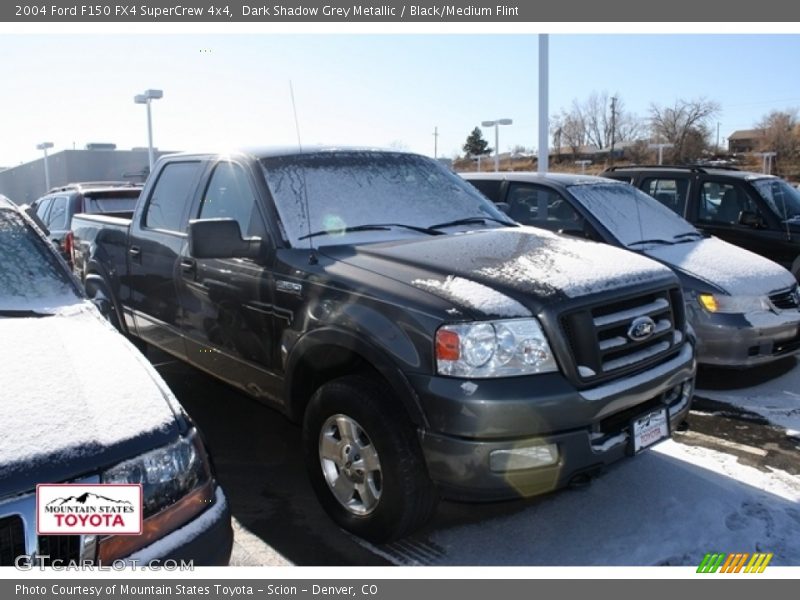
0;144;171;204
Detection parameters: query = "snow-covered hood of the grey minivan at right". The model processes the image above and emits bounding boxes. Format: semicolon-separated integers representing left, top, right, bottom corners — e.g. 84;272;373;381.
645;237;795;296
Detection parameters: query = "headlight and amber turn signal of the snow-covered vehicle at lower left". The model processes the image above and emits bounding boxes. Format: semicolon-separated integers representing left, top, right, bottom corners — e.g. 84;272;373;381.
98;430;214;563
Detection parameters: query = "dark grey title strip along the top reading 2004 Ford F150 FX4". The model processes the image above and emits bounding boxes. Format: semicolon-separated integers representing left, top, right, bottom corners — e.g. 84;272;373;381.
0;0;800;23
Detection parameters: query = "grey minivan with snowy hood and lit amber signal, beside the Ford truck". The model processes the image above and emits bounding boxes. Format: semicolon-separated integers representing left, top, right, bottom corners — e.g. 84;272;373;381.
464;173;800;367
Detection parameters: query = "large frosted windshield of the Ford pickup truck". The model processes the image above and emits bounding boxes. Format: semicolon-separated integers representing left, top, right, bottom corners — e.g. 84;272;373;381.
261;151;514;247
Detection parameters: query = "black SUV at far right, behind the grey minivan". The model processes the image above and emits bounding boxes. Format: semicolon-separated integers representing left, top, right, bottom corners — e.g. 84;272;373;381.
602;166;800;281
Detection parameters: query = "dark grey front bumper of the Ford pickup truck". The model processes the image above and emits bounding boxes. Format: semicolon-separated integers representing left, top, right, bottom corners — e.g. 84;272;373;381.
412;344;696;500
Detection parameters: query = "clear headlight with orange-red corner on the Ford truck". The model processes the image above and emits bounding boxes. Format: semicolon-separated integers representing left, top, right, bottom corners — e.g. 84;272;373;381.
436;319;558;379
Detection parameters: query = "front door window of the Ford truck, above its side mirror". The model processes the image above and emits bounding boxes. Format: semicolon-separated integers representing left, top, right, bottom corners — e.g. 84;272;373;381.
199;162;264;237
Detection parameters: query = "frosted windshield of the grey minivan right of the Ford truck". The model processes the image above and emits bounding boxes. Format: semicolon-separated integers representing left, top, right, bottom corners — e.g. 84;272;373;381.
569;182;701;248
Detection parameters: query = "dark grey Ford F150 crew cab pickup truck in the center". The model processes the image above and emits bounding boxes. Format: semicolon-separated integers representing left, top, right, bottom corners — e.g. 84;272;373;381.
73;148;695;541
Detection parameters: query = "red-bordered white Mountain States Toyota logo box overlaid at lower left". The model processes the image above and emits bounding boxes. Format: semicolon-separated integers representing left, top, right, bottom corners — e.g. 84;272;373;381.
36;483;142;535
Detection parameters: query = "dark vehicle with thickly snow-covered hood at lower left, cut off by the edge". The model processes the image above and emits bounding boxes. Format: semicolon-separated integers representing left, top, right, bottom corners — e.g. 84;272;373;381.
0;197;233;568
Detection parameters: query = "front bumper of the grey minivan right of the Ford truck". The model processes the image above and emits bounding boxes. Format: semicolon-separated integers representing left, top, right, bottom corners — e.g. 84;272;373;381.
689;309;800;368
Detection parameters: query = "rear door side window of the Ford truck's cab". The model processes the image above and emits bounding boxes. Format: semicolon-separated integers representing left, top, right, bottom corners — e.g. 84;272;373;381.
144;162;202;231
